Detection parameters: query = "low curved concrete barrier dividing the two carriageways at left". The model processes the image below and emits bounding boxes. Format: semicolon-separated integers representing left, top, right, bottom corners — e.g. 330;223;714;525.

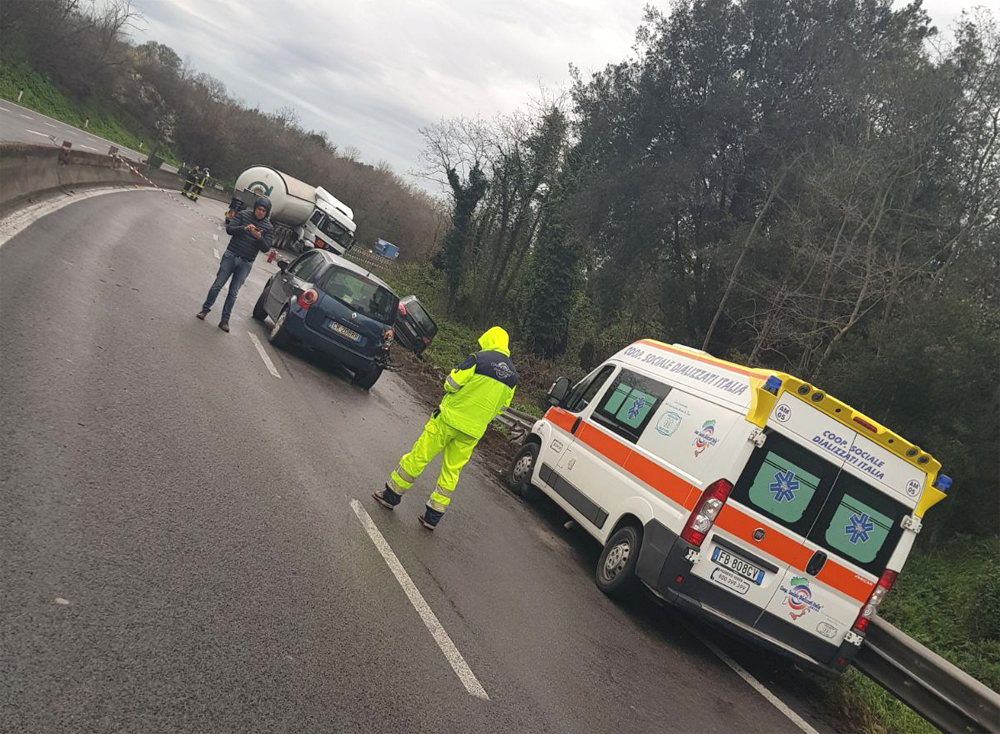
0;143;229;216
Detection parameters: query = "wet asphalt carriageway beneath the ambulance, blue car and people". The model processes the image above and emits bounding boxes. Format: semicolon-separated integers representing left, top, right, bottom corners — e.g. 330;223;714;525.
0;191;852;734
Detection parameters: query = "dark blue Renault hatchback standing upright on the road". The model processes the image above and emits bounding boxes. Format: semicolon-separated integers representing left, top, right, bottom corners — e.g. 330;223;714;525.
253;250;399;390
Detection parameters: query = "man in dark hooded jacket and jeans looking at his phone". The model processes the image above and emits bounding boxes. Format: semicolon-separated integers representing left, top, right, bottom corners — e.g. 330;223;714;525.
198;196;274;332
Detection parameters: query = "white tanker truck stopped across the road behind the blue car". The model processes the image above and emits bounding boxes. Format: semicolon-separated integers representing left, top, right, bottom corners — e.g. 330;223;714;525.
226;165;357;255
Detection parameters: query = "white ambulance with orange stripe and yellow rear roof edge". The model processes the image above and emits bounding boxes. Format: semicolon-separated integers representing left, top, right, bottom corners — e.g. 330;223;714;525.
507;340;951;675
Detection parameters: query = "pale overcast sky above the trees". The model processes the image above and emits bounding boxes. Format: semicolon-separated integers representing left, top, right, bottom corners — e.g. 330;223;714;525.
133;0;984;190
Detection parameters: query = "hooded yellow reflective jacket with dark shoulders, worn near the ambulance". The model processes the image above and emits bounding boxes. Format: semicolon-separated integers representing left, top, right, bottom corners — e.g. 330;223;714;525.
441;326;517;438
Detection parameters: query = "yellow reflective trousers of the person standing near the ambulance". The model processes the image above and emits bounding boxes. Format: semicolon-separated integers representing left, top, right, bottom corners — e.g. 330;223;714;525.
389;415;479;512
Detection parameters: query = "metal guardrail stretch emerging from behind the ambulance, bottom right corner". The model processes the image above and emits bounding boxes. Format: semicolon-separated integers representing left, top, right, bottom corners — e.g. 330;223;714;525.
854;617;1000;734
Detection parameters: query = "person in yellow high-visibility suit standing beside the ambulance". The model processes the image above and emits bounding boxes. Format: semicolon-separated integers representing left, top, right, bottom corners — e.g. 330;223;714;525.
372;326;517;530
